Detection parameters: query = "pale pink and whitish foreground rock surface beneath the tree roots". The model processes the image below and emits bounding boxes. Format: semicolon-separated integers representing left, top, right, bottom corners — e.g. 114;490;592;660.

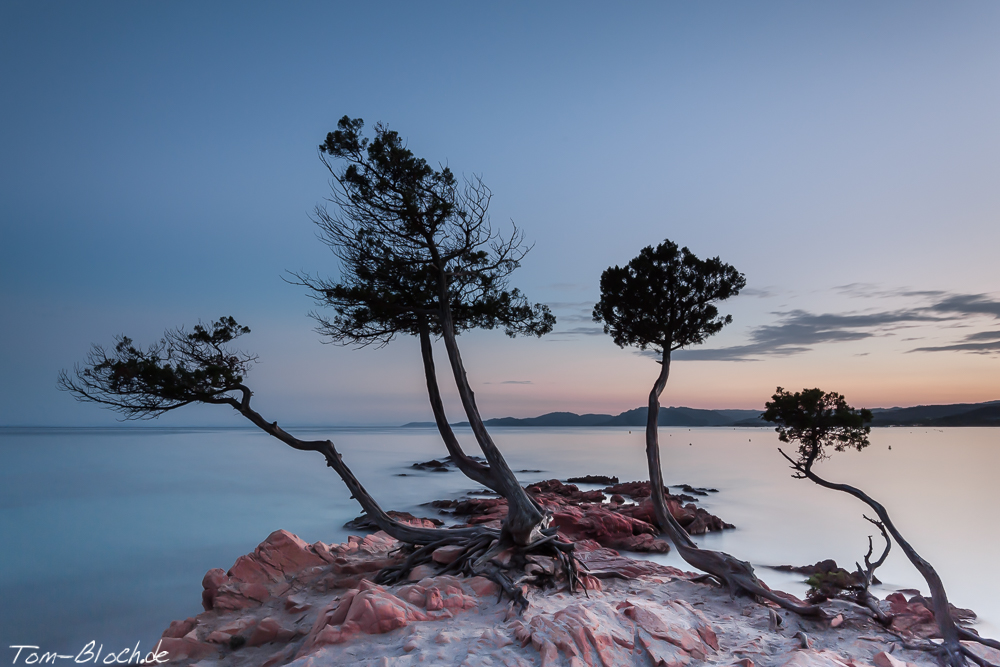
152;531;980;667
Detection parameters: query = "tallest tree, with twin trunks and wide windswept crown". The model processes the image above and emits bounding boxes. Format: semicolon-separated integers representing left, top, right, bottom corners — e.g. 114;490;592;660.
295;116;555;549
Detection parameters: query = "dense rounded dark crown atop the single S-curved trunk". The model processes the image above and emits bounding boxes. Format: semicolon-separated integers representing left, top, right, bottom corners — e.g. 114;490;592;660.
594;240;746;353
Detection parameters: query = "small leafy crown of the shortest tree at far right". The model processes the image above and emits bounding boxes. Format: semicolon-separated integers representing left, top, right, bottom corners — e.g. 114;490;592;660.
761;387;872;470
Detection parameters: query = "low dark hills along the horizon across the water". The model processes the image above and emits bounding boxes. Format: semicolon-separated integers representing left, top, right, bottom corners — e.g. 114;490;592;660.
403;401;1000;428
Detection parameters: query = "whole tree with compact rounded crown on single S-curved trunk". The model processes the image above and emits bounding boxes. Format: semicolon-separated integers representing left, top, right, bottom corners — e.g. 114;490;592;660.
593;240;820;615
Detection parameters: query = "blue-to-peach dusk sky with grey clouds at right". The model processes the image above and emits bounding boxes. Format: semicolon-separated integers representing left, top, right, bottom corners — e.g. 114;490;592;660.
0;0;1000;426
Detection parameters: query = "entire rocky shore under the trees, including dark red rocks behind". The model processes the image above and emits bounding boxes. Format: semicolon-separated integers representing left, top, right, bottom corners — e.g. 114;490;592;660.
150;480;1000;667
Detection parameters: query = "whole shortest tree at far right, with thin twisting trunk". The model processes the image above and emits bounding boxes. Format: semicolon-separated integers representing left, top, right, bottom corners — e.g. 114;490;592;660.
761;387;1000;667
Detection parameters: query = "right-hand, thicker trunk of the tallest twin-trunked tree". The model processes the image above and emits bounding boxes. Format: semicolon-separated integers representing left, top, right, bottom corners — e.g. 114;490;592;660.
441;300;549;546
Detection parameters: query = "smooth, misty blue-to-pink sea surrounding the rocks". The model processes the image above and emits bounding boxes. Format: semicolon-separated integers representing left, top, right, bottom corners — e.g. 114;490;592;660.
0;428;1000;652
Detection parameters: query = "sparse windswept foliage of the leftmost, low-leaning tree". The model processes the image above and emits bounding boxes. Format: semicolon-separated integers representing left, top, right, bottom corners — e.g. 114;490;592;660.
59;317;256;419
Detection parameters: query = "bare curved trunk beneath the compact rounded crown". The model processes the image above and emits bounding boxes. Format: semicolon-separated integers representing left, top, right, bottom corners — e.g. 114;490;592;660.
646;349;822;616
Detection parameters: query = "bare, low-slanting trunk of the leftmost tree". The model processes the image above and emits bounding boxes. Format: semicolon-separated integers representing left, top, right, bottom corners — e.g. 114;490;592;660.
220;388;496;544
